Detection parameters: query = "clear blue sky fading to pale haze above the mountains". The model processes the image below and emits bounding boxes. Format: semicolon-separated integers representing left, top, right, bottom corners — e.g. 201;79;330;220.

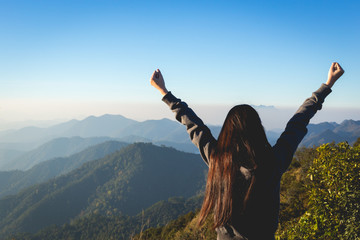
0;0;360;130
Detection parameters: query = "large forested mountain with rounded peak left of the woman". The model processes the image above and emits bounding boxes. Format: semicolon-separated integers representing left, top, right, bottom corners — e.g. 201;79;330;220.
0;143;206;237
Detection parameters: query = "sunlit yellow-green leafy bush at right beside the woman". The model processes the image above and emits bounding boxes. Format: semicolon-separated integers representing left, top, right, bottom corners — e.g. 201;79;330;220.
279;143;360;239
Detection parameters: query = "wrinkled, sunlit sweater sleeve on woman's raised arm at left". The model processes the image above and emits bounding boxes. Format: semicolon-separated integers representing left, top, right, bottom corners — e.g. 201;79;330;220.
162;92;216;165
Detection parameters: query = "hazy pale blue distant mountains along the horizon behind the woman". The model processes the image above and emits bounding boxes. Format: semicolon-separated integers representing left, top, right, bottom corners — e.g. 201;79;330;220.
0;115;360;170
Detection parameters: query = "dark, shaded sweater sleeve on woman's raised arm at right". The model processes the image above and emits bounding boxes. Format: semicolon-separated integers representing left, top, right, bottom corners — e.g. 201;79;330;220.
273;84;331;174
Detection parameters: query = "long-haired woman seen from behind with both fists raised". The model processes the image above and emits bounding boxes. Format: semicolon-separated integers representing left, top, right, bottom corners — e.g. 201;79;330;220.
150;63;344;240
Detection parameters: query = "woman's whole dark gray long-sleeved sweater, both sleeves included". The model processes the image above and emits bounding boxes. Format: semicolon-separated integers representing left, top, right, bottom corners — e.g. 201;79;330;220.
163;84;331;240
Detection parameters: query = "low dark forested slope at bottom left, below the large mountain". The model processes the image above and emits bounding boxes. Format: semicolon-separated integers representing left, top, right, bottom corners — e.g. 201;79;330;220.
8;196;202;240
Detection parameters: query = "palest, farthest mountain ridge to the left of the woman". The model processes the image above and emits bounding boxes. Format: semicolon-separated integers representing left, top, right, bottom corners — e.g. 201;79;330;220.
0;114;193;146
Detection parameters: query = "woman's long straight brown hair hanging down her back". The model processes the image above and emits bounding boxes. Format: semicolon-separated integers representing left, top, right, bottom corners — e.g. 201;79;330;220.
198;105;270;228
